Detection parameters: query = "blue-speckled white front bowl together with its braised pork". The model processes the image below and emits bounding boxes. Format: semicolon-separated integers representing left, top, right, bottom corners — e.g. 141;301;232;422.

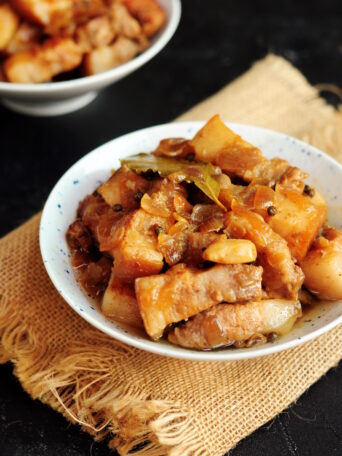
41;117;342;360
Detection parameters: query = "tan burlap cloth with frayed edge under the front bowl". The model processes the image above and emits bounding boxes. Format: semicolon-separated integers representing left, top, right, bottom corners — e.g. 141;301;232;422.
0;56;342;456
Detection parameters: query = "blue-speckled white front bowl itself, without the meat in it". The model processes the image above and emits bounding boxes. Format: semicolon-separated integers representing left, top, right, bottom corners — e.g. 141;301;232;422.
40;122;342;361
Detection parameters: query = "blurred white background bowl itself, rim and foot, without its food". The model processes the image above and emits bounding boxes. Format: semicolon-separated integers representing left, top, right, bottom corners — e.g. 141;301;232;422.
0;0;181;116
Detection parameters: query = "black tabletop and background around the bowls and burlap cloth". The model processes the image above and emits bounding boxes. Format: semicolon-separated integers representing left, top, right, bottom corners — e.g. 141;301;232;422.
0;0;342;456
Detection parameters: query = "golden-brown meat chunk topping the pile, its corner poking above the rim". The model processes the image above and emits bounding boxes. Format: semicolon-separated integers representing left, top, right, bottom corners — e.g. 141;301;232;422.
189;115;307;186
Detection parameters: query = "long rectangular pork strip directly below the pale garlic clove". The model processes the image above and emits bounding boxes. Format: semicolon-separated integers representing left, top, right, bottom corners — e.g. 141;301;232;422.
135;264;262;339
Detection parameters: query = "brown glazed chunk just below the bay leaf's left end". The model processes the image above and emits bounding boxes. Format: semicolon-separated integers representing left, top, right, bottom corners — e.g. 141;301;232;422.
97;166;150;211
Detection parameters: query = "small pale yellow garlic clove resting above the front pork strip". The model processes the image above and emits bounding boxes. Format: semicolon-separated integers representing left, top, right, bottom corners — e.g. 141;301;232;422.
203;234;257;264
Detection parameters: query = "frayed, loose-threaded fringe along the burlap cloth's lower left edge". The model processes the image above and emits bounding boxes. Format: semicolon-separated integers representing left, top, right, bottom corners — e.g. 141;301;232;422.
0;278;206;456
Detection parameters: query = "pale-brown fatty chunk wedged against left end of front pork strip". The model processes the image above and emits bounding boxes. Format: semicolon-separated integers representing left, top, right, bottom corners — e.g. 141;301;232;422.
101;273;144;328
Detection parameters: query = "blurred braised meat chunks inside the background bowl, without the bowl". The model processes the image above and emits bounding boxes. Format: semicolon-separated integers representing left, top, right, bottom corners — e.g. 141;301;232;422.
0;0;165;84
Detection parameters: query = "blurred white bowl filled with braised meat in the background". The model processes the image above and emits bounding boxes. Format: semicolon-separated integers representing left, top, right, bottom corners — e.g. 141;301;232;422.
0;0;180;115
